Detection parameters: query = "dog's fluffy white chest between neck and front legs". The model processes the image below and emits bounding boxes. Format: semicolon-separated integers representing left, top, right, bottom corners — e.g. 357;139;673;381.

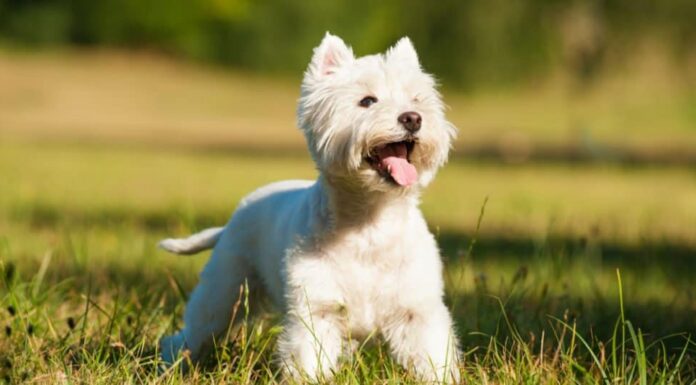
288;210;437;338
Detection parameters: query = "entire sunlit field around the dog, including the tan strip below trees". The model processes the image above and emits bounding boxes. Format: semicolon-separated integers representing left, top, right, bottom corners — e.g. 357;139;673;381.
0;53;696;384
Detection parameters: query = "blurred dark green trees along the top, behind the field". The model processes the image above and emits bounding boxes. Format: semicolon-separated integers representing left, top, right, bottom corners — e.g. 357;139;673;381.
0;0;696;87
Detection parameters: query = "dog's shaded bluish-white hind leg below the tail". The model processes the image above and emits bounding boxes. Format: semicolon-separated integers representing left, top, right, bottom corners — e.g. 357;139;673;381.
160;229;250;364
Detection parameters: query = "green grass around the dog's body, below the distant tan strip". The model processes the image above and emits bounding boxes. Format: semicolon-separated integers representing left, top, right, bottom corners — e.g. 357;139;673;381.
0;142;696;383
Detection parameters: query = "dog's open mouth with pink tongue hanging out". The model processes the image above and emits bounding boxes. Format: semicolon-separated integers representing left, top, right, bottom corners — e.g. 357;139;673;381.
365;140;418;186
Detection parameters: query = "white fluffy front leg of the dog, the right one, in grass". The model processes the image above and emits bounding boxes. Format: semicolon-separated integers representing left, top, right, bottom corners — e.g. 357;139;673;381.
384;302;459;383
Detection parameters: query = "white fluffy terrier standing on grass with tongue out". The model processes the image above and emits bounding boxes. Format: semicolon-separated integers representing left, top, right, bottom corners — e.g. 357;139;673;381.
161;33;459;382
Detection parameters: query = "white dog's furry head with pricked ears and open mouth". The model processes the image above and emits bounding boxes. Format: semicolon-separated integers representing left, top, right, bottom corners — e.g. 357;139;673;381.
298;33;455;191
